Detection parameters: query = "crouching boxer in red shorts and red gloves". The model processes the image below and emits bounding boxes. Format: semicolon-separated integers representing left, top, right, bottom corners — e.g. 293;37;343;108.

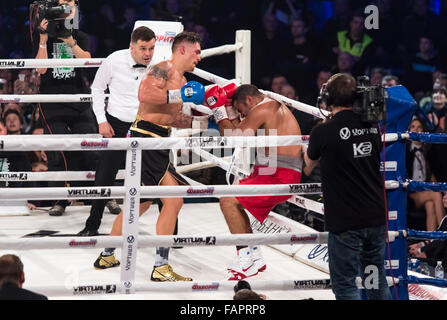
205;84;303;280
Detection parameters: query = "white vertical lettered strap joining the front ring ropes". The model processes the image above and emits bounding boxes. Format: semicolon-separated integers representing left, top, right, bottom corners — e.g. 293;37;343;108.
121;139;141;294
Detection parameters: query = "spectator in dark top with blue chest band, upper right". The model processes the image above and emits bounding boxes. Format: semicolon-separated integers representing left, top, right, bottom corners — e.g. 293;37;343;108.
405;35;438;100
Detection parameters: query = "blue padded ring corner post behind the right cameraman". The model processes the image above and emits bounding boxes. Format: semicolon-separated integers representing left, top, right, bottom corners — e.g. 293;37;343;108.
382;86;416;300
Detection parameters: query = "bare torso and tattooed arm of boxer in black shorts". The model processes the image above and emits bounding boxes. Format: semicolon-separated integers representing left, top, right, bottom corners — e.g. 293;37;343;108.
138;61;186;126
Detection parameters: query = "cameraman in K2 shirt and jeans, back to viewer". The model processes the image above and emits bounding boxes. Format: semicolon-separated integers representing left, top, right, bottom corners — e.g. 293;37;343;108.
304;73;391;300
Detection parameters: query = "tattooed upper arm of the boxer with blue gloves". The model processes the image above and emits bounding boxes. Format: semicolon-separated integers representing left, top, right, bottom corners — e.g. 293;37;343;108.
138;61;173;104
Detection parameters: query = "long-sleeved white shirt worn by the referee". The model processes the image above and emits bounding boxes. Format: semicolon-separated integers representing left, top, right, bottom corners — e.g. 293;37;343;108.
91;49;149;124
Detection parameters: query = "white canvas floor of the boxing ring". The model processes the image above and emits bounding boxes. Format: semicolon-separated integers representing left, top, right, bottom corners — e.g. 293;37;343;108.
0;203;334;300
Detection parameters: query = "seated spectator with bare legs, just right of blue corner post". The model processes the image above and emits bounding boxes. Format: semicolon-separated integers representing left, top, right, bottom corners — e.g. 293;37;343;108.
406;118;445;231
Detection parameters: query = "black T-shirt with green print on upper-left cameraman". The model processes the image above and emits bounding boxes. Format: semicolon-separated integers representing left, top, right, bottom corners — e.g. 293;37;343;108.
33;29;90;95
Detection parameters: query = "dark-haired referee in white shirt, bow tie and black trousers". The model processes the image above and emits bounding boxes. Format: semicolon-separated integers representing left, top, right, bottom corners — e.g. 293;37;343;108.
78;27;155;236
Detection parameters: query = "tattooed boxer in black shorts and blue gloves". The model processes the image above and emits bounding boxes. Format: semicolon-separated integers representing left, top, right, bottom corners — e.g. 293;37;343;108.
94;32;205;281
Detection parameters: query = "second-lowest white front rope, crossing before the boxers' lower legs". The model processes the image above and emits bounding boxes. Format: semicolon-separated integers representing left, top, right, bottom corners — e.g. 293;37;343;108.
0;232;328;250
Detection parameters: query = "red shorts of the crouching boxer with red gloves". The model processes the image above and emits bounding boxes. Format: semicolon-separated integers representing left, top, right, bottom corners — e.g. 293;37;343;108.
236;165;301;223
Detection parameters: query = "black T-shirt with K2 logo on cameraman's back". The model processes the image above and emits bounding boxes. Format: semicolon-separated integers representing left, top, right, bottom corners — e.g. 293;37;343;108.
307;110;385;232
